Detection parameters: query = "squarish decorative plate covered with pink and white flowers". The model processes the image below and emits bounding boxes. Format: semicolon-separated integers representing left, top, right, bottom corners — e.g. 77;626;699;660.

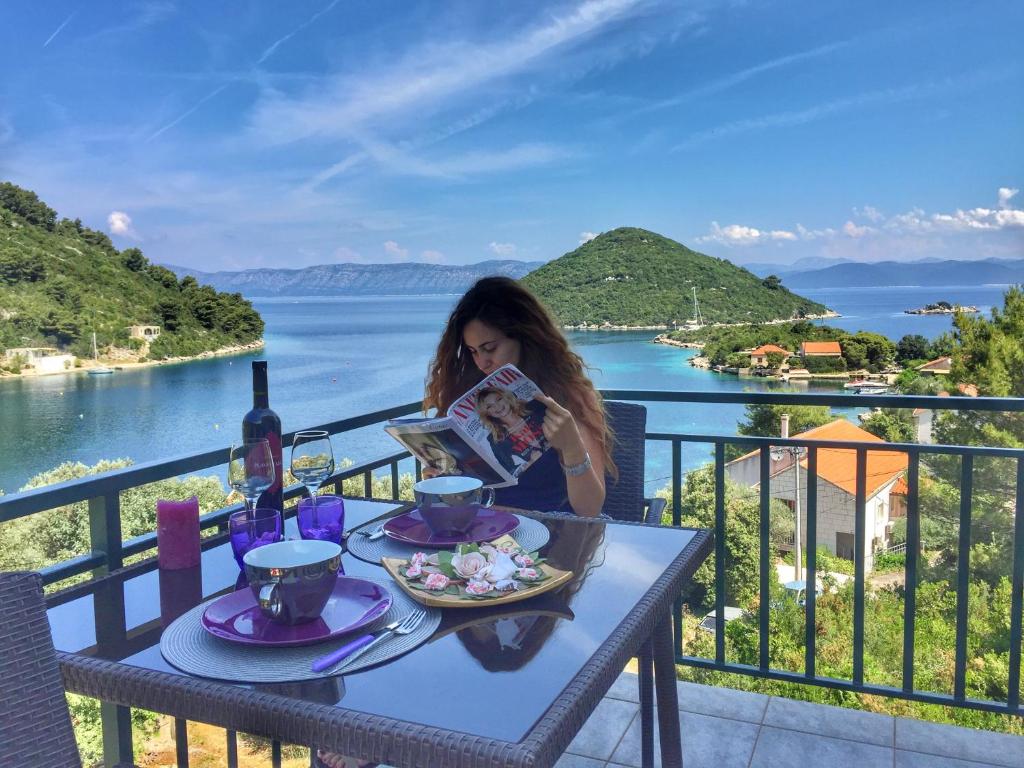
381;536;572;608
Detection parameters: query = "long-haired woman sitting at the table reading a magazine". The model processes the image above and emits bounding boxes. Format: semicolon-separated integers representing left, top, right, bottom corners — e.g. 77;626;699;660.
423;278;617;516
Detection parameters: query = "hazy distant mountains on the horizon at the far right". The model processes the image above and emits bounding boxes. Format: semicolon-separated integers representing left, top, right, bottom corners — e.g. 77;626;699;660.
770;259;1024;288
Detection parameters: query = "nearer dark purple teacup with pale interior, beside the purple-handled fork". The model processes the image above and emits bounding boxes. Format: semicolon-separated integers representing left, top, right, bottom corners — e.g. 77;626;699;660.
244;540;341;624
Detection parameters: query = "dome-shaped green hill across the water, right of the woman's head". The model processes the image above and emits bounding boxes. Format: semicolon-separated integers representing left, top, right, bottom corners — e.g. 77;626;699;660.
522;227;828;327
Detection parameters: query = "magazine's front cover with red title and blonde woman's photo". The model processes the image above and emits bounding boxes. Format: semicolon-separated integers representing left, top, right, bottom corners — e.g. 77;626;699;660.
449;366;549;477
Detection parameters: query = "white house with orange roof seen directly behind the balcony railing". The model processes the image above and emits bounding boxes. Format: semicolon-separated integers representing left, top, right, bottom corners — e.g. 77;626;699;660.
725;419;908;569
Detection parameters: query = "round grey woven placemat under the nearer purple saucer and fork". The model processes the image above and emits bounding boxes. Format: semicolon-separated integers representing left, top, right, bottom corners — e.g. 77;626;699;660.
160;575;441;683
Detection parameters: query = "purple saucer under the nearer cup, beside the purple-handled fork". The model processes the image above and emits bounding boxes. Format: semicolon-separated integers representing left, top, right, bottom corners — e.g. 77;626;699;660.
202;575;391;646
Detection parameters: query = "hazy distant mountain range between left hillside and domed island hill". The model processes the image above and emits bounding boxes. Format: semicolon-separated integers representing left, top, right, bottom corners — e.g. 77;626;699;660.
165;259;544;298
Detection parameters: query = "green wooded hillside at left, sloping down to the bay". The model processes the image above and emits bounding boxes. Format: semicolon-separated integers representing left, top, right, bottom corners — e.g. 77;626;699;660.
0;182;263;359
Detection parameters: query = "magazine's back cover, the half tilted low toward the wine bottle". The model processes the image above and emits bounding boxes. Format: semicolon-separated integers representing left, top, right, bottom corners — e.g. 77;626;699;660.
384;418;515;487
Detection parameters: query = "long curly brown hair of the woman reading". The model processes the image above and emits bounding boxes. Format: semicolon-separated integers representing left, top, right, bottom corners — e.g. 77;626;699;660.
423;278;618;478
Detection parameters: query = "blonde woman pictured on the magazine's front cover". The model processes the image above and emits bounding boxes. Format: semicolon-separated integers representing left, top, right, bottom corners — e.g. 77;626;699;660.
476;387;547;475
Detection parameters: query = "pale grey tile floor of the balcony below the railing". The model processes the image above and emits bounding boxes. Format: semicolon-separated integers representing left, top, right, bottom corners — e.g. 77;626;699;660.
556;672;1024;768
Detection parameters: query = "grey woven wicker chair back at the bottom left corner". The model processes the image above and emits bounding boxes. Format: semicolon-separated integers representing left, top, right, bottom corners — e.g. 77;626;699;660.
0;572;82;768
